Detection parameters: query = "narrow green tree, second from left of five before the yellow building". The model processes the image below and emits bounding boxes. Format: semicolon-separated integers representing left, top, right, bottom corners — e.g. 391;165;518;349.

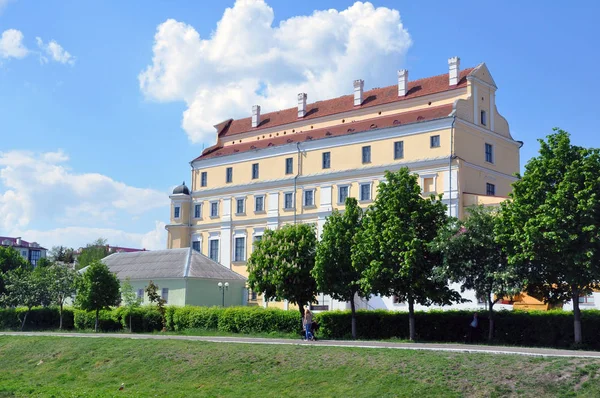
312;198;368;339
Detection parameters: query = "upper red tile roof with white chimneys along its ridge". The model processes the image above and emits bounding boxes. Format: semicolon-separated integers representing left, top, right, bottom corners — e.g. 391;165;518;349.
220;68;474;140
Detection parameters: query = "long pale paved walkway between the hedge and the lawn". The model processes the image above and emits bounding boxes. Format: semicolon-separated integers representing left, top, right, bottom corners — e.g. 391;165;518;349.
0;332;600;359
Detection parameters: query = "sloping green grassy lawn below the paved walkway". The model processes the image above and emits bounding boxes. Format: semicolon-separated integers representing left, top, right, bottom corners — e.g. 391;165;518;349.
0;336;600;397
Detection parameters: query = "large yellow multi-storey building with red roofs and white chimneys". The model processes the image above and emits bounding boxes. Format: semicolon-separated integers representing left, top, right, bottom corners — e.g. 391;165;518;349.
166;57;522;308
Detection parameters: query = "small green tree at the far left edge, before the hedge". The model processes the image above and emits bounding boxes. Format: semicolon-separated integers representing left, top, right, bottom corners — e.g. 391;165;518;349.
2;267;48;331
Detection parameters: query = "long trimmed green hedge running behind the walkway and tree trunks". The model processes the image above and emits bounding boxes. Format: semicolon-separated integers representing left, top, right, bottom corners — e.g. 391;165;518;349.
0;306;600;350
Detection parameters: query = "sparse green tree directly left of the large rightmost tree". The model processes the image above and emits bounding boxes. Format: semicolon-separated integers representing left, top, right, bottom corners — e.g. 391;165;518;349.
439;206;523;341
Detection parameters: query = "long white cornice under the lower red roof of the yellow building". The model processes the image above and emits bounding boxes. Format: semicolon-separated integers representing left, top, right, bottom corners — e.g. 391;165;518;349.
192;117;453;170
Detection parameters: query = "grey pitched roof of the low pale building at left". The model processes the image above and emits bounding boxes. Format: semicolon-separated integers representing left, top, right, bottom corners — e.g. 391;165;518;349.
102;248;246;281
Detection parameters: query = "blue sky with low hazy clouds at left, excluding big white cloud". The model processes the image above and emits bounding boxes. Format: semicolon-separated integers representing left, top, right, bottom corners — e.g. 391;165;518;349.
0;0;600;248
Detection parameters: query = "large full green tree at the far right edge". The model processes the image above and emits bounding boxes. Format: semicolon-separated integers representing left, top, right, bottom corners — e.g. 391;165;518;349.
497;129;600;344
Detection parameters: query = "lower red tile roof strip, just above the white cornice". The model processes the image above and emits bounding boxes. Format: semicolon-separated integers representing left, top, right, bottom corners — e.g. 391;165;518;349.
194;104;453;160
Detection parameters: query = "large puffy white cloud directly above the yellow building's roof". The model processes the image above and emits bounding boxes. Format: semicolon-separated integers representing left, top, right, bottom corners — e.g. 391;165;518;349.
138;0;411;142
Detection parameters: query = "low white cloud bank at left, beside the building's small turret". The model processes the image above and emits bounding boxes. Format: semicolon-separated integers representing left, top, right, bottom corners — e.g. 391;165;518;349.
0;151;169;248
